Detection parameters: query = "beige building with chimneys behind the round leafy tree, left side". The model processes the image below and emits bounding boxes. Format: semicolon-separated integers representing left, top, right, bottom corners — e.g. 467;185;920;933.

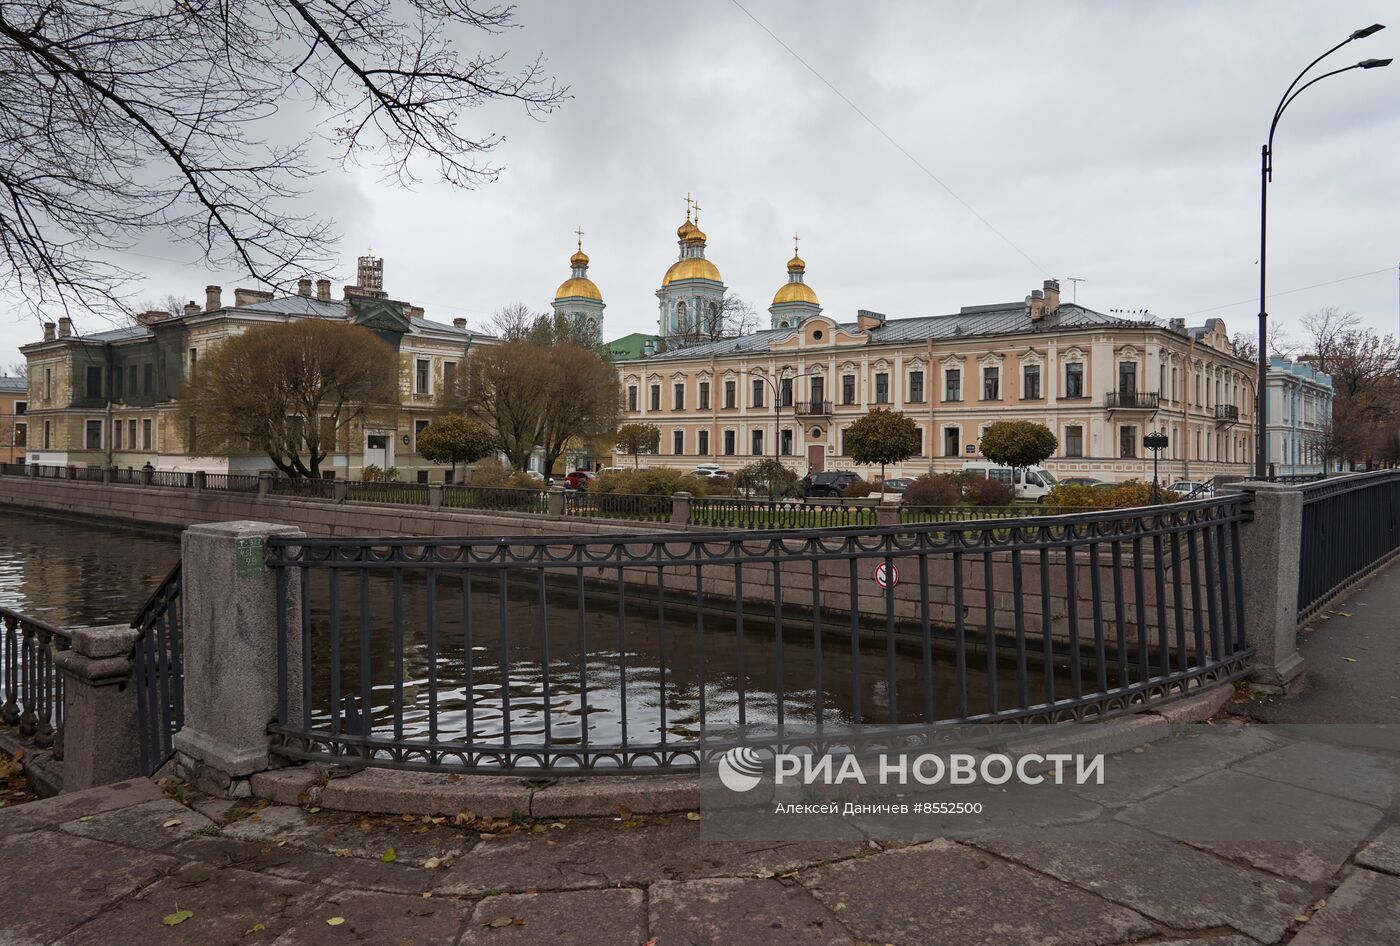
21;256;494;481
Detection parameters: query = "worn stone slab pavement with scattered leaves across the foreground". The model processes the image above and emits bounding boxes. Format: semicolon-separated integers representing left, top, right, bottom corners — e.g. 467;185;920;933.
10;568;1400;946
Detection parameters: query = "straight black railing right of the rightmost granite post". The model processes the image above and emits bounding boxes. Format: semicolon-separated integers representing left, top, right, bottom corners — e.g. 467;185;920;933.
1298;470;1400;621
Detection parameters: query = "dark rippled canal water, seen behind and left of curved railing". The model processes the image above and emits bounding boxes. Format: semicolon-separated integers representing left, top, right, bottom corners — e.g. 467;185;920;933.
0;511;1042;746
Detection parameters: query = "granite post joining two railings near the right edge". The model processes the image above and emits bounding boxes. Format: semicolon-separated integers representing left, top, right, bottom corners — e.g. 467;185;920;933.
1225;480;1303;689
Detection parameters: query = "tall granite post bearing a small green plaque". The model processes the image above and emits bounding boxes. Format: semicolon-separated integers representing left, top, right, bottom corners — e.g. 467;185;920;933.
175;522;305;798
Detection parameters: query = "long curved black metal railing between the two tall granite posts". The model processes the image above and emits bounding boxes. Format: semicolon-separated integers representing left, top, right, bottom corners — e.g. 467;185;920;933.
267;494;1252;775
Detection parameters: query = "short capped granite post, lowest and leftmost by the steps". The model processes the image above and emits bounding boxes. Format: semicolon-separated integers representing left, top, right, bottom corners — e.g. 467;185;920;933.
53;624;140;792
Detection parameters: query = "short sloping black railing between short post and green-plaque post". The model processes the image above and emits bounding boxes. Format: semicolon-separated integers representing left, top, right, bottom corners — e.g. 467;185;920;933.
132;563;185;775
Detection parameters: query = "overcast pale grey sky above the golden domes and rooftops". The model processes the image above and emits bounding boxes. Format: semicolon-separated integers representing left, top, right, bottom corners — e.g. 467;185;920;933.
0;0;1400;364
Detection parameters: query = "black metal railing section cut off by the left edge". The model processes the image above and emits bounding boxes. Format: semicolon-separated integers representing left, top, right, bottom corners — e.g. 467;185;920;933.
0;607;73;749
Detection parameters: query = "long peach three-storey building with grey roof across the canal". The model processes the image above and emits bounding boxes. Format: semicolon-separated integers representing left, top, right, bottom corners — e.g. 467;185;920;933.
613;255;1254;481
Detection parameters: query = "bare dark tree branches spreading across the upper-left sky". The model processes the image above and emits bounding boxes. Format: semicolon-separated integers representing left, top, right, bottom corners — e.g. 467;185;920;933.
0;0;567;321
